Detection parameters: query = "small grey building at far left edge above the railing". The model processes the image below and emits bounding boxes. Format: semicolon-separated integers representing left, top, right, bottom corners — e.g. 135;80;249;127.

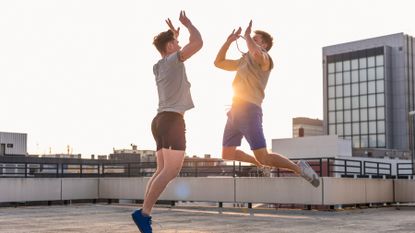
0;132;27;156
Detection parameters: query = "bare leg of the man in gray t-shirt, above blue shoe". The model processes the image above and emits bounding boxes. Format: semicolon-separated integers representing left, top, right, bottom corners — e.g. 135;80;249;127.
143;148;184;215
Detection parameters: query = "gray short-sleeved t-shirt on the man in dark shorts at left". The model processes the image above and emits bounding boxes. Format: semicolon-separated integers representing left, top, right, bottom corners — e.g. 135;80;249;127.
153;52;194;113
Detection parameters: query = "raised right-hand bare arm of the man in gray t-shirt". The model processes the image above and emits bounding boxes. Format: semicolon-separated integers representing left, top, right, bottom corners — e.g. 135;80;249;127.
177;11;203;61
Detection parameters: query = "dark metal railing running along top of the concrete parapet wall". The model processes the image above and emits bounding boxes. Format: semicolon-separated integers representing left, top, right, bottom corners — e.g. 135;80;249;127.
0;157;396;178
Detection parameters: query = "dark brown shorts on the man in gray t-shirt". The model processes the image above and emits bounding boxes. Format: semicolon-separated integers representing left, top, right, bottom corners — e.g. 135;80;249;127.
151;112;186;151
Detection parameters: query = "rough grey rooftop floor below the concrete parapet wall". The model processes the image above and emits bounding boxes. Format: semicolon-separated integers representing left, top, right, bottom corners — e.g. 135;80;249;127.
0;204;415;233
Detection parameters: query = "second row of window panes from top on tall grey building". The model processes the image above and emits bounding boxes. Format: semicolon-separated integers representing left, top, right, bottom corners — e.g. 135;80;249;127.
328;66;385;86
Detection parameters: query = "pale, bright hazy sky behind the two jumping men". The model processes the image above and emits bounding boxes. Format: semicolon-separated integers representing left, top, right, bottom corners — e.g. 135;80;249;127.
0;0;415;157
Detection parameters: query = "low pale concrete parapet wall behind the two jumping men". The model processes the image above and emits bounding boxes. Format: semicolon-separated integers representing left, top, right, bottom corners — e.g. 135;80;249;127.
0;177;415;205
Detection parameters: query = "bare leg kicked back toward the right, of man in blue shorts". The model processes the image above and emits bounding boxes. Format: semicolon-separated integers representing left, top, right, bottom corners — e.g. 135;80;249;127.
253;148;301;174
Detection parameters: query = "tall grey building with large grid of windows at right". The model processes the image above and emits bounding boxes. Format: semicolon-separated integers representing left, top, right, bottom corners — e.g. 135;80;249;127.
323;33;415;157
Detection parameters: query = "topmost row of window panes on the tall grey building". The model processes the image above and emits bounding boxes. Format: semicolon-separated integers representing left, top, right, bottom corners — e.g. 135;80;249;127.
328;55;384;73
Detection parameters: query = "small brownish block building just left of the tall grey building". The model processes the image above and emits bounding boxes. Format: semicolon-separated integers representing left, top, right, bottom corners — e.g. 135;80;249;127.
293;117;324;138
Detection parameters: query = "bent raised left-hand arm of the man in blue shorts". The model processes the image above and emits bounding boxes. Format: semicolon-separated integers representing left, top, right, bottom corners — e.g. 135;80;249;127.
215;27;242;71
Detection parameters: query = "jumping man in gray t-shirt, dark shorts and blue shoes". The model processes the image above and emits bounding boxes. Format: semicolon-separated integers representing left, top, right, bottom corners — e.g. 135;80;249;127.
132;11;203;233
